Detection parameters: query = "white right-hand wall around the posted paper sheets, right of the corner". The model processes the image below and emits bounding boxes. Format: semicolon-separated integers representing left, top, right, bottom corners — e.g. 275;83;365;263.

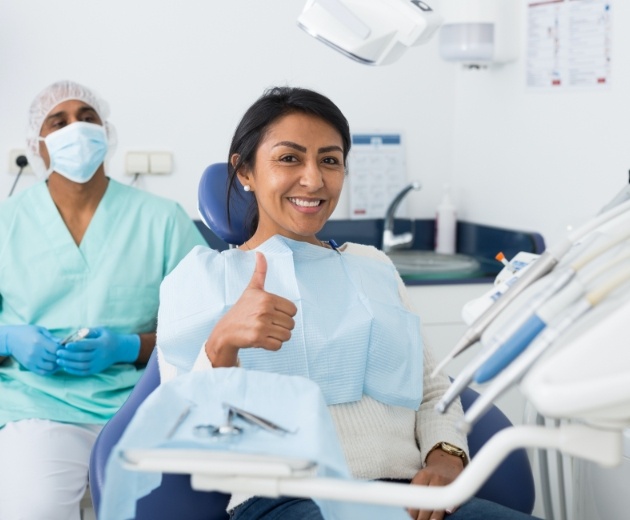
450;0;630;244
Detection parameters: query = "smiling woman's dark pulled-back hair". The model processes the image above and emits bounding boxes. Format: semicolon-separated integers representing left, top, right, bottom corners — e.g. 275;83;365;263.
227;87;351;237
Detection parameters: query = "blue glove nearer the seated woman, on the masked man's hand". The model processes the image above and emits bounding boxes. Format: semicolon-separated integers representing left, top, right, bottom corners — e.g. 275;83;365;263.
57;327;140;376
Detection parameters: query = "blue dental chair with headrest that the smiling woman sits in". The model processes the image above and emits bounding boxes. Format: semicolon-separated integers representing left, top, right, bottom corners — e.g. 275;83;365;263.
89;163;535;520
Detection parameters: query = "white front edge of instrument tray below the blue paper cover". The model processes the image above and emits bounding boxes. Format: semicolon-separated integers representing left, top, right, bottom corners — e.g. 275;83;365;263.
120;448;317;477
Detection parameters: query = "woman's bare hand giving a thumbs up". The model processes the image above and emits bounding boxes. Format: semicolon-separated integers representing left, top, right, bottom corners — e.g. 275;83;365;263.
205;252;297;367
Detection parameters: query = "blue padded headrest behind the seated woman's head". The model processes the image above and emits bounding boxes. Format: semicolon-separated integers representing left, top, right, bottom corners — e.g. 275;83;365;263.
197;163;255;245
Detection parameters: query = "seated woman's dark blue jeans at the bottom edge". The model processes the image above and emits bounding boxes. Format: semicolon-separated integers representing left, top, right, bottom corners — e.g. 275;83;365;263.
230;497;535;520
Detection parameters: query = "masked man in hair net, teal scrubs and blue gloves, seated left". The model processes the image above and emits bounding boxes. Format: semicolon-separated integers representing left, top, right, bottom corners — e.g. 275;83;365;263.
0;81;205;520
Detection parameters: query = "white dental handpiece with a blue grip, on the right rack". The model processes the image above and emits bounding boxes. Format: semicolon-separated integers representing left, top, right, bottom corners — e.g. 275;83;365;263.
435;241;630;413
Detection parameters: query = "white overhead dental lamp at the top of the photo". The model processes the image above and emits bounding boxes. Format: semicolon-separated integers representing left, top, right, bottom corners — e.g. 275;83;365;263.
297;0;442;65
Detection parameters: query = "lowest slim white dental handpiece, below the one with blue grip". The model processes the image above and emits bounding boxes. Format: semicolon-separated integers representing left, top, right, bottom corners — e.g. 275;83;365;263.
458;265;630;433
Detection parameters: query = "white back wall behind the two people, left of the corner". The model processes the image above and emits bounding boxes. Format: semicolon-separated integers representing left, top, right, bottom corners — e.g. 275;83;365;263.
0;0;456;218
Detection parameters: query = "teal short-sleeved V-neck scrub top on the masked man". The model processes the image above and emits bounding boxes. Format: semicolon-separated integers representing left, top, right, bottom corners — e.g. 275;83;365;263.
0;179;205;426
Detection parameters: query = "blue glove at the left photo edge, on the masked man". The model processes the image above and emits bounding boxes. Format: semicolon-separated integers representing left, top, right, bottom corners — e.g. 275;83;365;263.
0;325;59;376
